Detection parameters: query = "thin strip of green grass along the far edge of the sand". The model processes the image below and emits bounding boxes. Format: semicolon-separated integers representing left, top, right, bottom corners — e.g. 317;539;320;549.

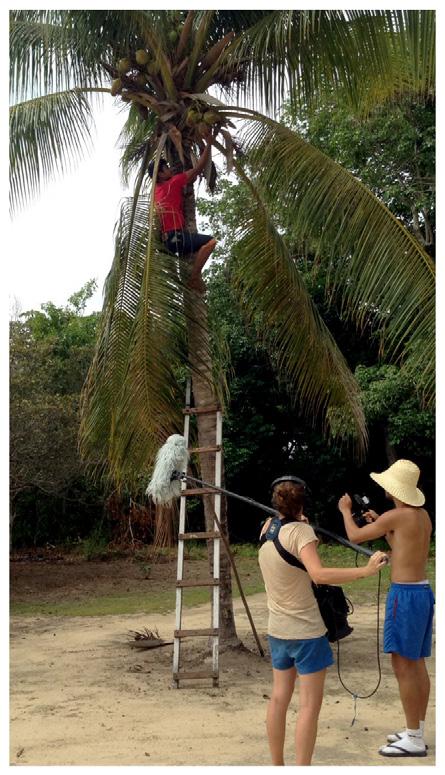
11;544;435;616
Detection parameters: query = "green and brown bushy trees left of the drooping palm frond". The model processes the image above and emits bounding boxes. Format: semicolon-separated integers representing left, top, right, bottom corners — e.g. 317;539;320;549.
10;283;102;543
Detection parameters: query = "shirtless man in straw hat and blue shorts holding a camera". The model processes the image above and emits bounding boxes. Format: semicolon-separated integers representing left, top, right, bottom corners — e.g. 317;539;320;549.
338;460;434;757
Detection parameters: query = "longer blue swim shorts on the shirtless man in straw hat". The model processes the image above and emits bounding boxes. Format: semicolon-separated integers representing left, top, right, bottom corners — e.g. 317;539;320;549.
383;583;434;659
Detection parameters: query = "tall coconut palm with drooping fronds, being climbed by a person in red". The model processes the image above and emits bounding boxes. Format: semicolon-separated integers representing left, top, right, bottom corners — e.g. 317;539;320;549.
10;10;434;642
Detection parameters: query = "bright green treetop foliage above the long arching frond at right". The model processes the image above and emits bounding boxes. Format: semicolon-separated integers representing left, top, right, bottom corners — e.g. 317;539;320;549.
284;97;436;256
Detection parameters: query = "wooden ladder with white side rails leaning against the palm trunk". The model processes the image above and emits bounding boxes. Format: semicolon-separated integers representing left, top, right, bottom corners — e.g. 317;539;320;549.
173;380;222;689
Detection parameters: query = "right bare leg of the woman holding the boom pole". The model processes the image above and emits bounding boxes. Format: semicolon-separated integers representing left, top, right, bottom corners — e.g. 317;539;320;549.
295;668;326;765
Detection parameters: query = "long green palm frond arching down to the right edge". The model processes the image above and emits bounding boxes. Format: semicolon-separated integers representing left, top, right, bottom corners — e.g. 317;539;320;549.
236;115;435;403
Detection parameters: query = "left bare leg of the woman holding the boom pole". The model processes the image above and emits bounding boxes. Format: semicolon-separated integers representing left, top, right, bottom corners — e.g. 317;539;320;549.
266;667;297;766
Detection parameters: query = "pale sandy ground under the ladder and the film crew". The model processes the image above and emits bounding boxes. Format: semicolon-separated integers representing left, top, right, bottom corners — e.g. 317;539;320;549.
10;594;435;766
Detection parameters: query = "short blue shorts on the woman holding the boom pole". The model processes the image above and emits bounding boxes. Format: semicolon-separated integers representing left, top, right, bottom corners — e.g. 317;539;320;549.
268;635;334;675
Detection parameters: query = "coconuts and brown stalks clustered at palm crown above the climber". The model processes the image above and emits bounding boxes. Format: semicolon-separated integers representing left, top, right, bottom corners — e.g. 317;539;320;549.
102;11;241;190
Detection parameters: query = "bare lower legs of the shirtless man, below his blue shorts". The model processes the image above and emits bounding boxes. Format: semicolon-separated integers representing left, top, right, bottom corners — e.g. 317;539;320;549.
391;653;430;729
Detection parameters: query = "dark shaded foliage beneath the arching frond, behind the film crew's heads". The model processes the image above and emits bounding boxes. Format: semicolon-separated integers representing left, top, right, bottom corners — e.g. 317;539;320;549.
203;264;435;540
